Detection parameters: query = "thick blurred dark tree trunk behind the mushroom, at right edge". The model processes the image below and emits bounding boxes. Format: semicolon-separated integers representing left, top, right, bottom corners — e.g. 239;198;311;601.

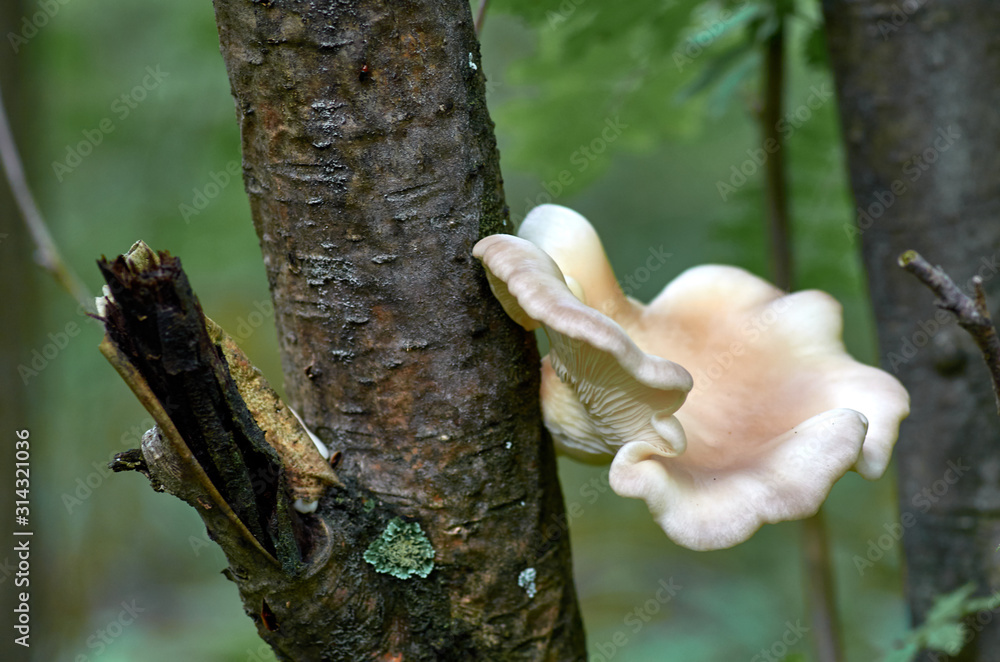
823;0;1000;661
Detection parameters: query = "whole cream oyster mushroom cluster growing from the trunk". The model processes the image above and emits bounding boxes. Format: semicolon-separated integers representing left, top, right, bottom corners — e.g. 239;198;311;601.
474;205;909;549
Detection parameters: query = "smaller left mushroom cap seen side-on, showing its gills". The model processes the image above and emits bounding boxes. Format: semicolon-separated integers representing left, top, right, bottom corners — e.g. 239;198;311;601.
473;235;691;461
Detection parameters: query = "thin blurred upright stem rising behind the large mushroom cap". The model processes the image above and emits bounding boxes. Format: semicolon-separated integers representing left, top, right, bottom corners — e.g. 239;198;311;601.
760;17;841;662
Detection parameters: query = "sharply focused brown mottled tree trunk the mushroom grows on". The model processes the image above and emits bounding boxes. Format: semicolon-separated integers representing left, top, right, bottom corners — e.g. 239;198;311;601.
215;0;585;660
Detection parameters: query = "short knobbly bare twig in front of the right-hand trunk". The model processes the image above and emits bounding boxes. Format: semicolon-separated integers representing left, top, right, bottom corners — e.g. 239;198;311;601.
899;251;1000;415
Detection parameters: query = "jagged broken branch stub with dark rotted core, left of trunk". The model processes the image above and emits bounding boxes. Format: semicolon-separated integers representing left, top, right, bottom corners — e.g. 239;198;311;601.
98;242;340;574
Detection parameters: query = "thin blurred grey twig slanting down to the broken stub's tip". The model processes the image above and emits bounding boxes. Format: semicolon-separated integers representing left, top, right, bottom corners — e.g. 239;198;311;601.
0;81;96;312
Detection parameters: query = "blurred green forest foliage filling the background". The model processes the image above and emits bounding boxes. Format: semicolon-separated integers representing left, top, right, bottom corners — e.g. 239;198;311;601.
3;0;936;662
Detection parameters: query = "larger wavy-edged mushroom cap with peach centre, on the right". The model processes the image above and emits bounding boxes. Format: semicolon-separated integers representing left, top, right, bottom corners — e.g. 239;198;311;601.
610;266;909;549
